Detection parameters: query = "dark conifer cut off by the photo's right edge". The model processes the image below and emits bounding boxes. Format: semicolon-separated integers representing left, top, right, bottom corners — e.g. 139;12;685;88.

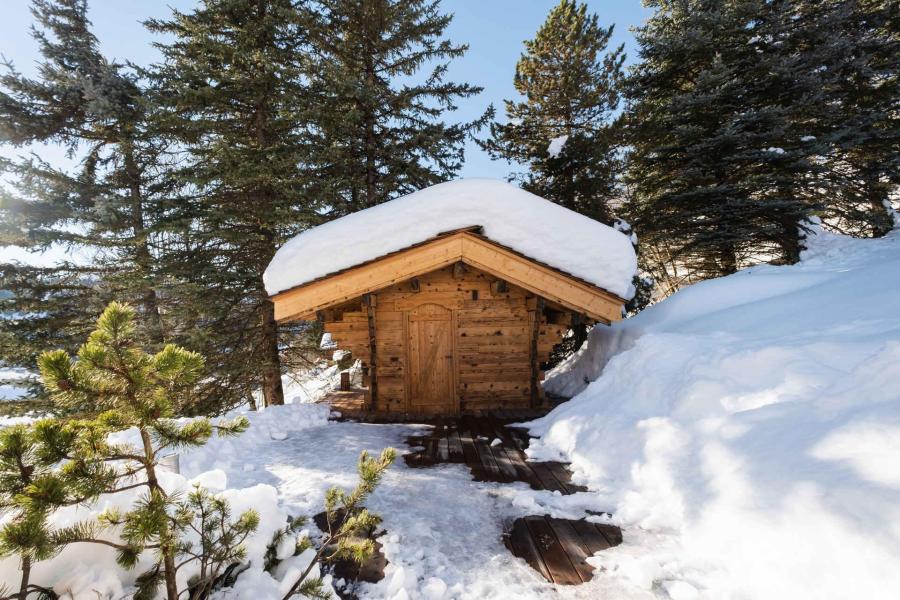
808;0;900;236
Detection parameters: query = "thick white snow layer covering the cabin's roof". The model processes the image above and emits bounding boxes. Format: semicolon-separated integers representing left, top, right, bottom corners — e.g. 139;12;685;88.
263;179;637;298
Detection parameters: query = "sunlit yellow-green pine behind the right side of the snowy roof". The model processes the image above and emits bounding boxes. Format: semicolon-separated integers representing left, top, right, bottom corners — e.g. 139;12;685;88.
482;0;625;224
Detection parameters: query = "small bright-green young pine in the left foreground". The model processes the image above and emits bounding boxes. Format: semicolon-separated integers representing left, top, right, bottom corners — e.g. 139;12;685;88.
38;302;250;600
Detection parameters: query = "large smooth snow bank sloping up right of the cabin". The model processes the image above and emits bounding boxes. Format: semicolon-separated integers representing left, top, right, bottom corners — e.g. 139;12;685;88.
531;226;900;600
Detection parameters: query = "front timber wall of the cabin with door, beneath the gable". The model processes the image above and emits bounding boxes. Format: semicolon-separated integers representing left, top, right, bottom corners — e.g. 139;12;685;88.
320;263;569;413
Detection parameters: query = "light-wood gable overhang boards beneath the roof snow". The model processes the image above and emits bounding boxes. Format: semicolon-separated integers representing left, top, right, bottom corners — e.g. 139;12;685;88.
272;228;625;323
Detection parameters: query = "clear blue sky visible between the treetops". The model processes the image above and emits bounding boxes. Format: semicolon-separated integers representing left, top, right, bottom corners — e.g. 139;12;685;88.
0;0;649;178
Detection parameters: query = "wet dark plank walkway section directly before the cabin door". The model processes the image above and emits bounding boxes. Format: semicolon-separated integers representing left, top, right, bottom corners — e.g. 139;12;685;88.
404;416;585;494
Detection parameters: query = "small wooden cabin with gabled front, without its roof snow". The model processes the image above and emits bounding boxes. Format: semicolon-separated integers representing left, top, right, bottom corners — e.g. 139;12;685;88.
272;224;624;415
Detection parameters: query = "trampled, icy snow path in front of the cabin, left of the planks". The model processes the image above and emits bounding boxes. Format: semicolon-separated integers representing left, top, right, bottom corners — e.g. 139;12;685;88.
192;422;647;600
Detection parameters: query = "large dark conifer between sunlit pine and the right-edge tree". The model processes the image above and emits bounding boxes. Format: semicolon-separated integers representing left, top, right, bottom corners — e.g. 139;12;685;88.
626;0;819;287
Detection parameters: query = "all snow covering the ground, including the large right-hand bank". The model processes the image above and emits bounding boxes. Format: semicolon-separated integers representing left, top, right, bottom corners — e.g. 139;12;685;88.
0;223;900;600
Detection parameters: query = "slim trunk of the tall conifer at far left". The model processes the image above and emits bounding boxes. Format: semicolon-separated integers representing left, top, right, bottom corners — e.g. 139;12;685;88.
123;142;165;346
